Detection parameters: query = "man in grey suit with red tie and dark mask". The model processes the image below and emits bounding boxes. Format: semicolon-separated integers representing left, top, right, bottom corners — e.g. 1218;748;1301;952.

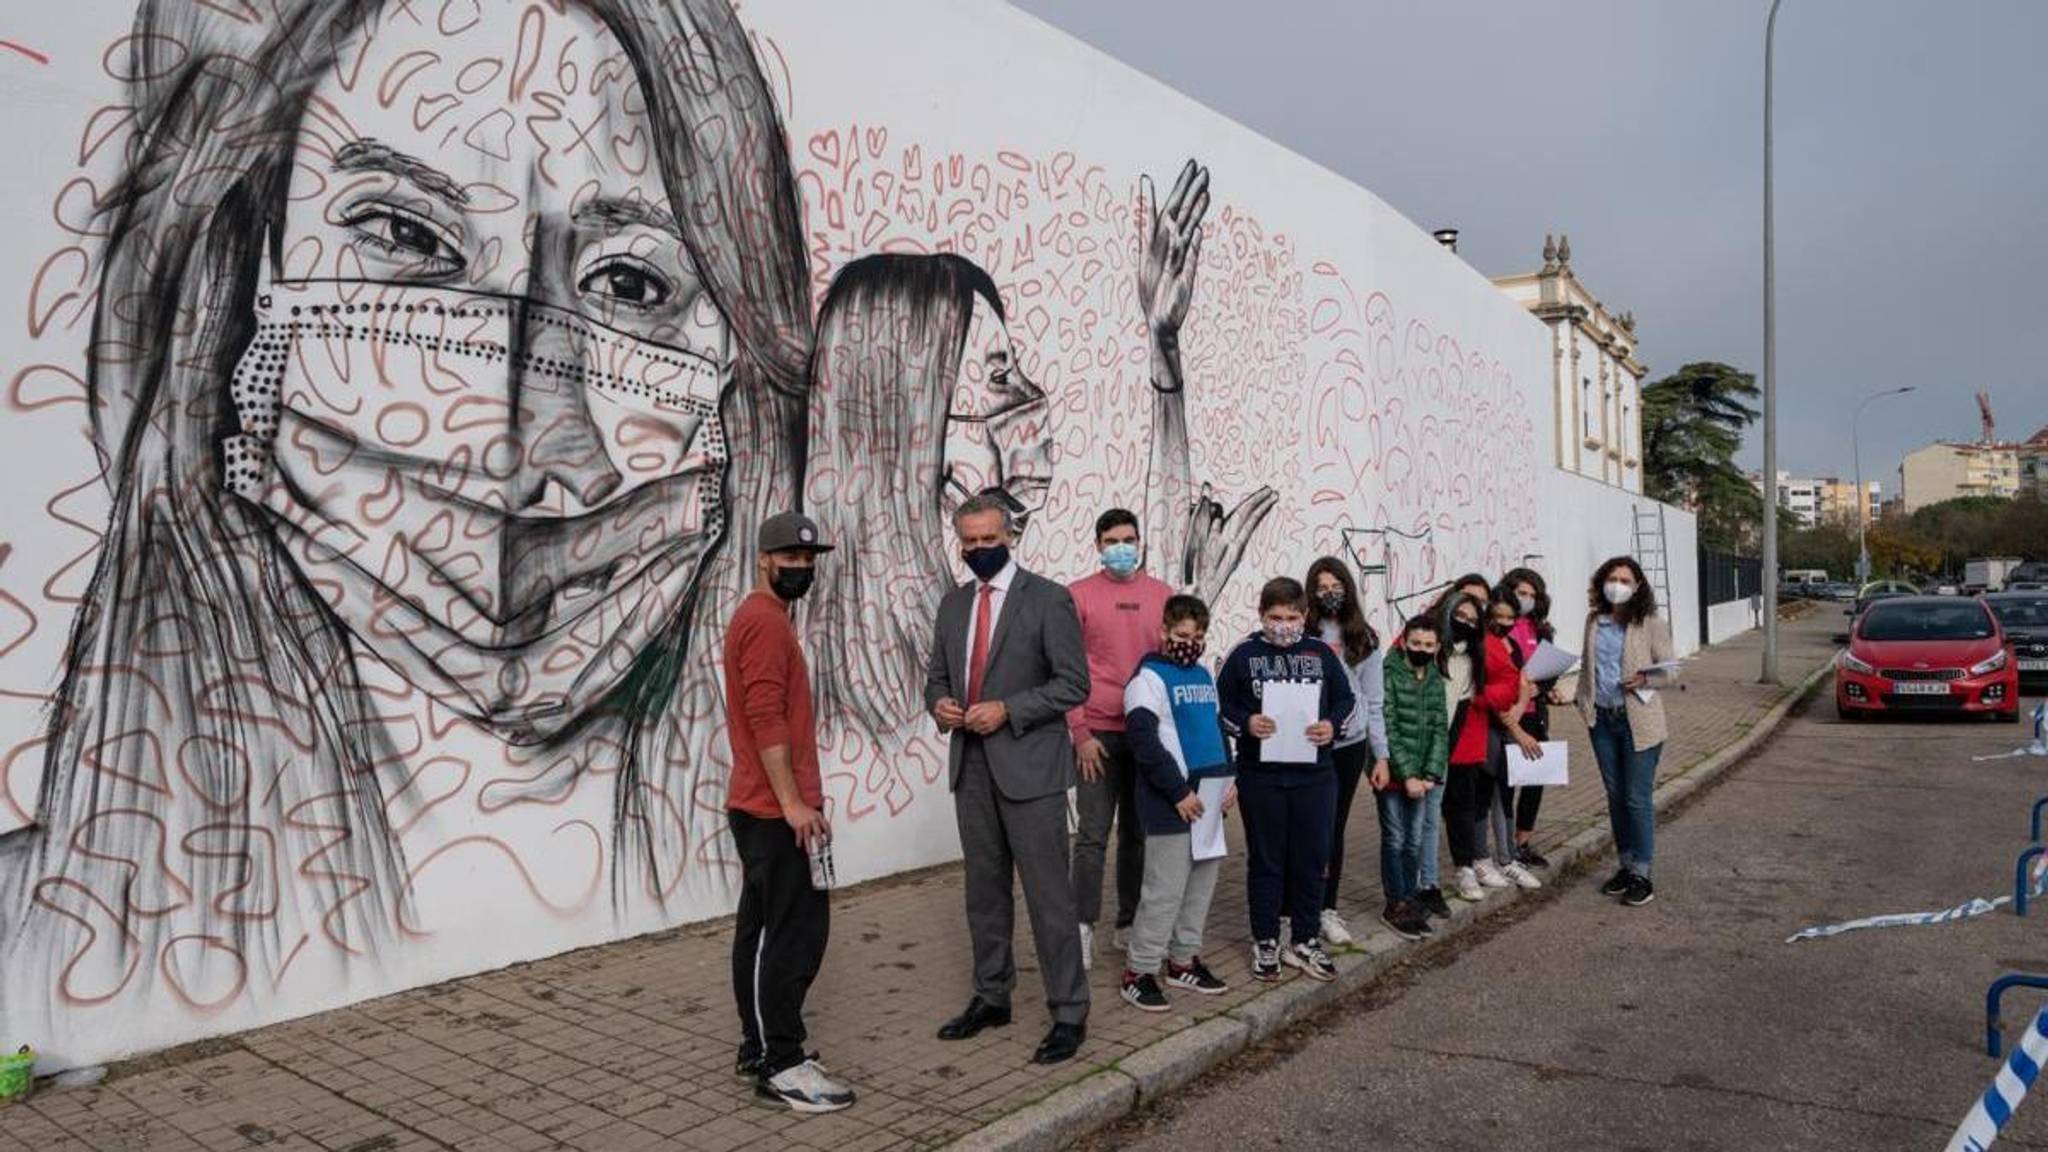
924;496;1087;1064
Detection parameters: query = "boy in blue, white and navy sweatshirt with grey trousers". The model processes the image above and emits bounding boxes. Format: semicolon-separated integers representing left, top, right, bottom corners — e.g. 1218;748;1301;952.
1122;596;1237;1013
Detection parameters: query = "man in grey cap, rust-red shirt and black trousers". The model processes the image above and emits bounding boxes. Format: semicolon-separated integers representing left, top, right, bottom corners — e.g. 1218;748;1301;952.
725;512;854;1113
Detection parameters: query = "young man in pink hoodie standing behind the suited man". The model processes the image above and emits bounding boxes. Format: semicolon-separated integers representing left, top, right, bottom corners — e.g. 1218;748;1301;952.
1067;508;1174;963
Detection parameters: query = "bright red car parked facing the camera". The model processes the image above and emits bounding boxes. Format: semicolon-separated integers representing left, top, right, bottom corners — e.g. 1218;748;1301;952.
1835;596;2019;722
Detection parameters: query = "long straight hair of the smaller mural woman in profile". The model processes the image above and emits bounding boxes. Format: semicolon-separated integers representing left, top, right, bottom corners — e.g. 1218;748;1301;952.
805;254;995;734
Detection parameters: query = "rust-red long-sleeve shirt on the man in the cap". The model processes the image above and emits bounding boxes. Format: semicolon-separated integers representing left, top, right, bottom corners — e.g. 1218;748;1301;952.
725;592;825;820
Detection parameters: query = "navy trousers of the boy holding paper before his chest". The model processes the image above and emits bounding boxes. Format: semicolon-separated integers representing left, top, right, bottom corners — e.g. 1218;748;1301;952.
1237;769;1337;941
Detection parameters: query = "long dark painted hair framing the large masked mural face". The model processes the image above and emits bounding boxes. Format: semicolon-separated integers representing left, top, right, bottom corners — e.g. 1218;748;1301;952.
0;0;809;1002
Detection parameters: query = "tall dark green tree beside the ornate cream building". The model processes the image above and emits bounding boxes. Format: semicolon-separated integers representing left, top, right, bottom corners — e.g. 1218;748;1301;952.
1642;361;1763;551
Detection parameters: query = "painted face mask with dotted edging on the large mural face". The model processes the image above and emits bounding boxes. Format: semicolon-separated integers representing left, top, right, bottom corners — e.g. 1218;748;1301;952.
221;281;727;742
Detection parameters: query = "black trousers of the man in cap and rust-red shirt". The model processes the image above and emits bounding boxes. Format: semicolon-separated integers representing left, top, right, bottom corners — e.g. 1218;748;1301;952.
725;812;831;1076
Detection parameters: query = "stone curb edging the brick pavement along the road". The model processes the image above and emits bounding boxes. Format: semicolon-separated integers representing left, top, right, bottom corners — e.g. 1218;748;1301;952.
948;660;1835;1152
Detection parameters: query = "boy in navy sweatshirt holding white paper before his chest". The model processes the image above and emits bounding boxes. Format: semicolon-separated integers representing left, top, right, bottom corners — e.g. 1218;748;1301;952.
1217;576;1358;980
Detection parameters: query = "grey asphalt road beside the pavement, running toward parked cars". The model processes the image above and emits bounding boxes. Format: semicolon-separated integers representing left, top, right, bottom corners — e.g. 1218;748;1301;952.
1094;685;2048;1152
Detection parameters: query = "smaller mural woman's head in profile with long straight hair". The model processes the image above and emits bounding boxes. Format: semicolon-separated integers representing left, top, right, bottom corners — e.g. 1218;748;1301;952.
805;254;1053;734
